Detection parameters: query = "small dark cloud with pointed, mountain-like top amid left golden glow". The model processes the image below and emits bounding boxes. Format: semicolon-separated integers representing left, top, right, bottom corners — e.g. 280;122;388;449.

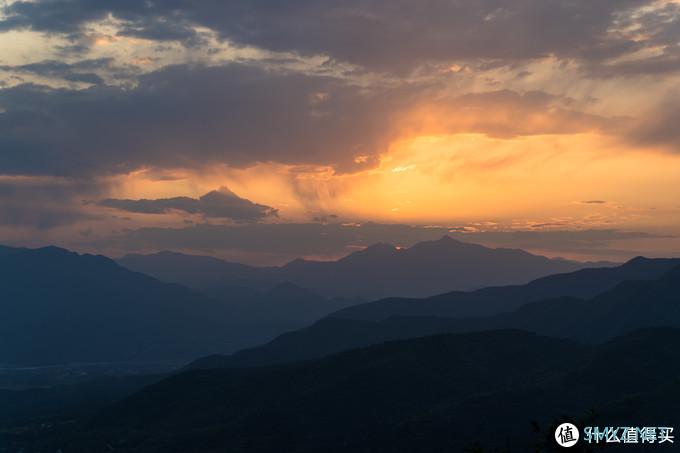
98;187;277;222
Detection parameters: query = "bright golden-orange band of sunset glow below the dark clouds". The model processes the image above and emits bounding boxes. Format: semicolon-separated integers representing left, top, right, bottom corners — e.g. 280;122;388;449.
105;128;680;228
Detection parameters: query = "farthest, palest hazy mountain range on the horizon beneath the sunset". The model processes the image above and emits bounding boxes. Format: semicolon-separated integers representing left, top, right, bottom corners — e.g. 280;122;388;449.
118;236;611;301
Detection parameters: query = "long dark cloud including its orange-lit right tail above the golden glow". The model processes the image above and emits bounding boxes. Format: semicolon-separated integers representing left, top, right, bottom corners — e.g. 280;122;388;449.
0;63;615;177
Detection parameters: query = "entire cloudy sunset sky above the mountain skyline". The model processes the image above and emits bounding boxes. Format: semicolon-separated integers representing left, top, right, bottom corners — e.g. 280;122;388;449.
0;0;680;264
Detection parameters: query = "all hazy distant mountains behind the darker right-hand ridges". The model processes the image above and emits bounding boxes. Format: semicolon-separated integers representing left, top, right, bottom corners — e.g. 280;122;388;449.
0;237;620;365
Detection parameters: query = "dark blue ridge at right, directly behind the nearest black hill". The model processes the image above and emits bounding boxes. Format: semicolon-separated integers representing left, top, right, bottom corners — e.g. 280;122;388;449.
188;258;680;369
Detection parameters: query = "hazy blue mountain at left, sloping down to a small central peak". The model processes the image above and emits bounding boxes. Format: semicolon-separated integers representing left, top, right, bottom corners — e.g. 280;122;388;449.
0;247;346;365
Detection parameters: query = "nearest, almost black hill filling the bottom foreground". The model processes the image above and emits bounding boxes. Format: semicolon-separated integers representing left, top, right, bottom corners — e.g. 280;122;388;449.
32;328;680;453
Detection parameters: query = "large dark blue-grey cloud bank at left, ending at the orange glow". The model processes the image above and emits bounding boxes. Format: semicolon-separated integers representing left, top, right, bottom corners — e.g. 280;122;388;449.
0;64;418;175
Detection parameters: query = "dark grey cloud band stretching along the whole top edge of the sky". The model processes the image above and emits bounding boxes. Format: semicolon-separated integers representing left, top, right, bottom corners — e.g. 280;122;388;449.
0;0;664;70
